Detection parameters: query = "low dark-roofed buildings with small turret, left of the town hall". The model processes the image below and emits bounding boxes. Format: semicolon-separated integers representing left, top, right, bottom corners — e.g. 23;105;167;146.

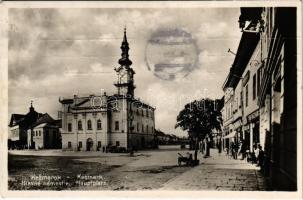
8;103;61;149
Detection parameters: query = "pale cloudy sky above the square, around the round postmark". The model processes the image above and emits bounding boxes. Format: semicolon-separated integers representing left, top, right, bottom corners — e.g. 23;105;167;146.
8;8;241;136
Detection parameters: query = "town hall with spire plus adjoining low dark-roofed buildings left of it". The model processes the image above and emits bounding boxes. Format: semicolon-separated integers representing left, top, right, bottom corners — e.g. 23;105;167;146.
9;30;155;151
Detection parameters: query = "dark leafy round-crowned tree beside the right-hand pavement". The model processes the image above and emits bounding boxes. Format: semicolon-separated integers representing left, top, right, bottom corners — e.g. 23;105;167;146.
175;98;223;160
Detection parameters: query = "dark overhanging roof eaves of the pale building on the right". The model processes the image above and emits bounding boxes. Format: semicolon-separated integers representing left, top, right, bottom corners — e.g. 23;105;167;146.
223;32;260;90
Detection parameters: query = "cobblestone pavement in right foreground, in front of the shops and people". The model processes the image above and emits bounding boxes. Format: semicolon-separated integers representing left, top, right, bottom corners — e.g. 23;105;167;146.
161;150;267;191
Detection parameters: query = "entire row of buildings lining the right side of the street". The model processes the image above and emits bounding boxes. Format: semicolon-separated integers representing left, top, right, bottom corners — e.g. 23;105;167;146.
222;7;297;190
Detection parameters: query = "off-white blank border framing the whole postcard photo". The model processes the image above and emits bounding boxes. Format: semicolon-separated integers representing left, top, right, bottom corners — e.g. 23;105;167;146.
0;0;302;199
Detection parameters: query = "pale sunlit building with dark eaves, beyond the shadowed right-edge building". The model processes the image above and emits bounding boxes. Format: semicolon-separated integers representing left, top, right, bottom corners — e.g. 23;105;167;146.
223;26;260;152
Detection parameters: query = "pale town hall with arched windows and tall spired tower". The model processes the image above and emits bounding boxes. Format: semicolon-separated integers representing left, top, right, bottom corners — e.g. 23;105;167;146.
59;28;155;151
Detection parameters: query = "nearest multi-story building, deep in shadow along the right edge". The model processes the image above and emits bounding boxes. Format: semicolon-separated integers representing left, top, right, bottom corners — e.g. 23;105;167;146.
258;7;298;190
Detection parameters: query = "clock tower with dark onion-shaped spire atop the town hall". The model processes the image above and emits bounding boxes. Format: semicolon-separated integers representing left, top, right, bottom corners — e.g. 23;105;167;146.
115;28;136;97
